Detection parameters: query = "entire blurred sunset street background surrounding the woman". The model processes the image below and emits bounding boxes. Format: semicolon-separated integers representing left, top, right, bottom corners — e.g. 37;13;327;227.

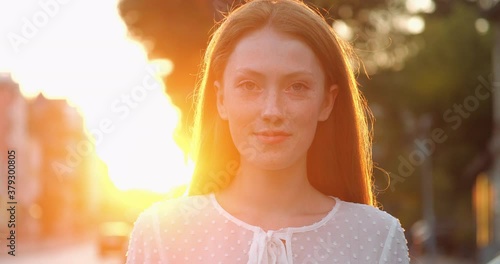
0;0;500;263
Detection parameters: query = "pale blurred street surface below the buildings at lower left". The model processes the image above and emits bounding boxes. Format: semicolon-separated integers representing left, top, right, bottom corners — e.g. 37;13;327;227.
0;240;125;264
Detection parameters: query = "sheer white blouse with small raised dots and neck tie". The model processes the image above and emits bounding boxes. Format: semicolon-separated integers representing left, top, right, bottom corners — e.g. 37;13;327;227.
127;194;409;264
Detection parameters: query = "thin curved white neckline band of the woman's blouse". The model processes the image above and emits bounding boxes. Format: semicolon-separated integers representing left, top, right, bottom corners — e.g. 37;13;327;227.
208;193;341;234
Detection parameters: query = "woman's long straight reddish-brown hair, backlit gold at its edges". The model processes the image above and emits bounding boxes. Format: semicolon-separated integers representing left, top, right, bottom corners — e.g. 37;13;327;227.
189;0;375;205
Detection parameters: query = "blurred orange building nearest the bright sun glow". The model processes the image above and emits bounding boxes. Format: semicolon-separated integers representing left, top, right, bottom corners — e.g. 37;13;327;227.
29;95;98;236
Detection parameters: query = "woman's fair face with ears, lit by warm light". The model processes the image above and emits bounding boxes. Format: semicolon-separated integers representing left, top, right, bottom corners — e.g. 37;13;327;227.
215;28;337;170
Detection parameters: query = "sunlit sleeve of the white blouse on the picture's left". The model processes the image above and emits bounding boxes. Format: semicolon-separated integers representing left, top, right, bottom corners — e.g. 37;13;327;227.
126;204;166;264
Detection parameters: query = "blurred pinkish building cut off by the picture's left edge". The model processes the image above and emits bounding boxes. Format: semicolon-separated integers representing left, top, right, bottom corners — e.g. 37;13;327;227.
0;73;42;241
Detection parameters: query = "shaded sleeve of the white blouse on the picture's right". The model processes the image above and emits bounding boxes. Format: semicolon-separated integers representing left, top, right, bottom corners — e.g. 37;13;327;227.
379;218;410;264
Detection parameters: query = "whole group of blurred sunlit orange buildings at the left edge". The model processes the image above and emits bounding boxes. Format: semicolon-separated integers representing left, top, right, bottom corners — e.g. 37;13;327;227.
0;74;101;241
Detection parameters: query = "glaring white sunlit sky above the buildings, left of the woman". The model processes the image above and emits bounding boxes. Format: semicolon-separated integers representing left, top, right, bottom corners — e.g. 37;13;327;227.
0;0;192;192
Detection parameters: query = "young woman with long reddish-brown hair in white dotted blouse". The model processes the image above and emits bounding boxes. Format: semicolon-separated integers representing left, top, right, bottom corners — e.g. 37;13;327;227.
127;0;409;263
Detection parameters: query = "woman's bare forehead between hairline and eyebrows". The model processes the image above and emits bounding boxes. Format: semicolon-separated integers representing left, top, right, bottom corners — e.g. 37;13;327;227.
224;27;324;78
